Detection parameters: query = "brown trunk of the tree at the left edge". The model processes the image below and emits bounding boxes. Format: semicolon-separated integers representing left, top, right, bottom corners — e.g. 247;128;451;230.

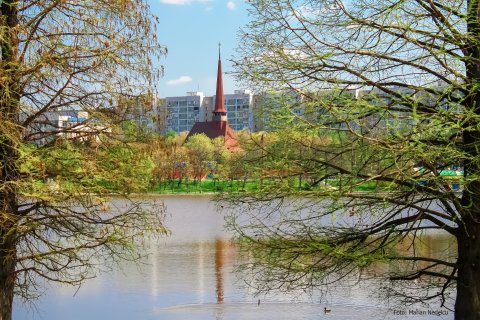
0;0;21;320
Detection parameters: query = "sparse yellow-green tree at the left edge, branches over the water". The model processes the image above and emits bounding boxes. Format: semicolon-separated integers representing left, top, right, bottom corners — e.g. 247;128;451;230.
0;0;165;320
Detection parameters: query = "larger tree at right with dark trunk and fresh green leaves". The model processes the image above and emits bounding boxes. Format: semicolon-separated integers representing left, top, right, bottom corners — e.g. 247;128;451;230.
230;0;480;319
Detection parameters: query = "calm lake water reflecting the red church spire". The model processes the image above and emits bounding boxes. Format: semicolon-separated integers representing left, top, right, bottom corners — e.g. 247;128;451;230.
14;196;453;320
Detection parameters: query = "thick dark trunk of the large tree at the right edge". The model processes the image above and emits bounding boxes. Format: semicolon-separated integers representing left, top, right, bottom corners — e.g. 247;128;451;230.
462;0;480;320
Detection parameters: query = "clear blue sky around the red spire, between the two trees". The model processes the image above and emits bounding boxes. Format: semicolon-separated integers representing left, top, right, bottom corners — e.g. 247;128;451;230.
150;0;248;97
